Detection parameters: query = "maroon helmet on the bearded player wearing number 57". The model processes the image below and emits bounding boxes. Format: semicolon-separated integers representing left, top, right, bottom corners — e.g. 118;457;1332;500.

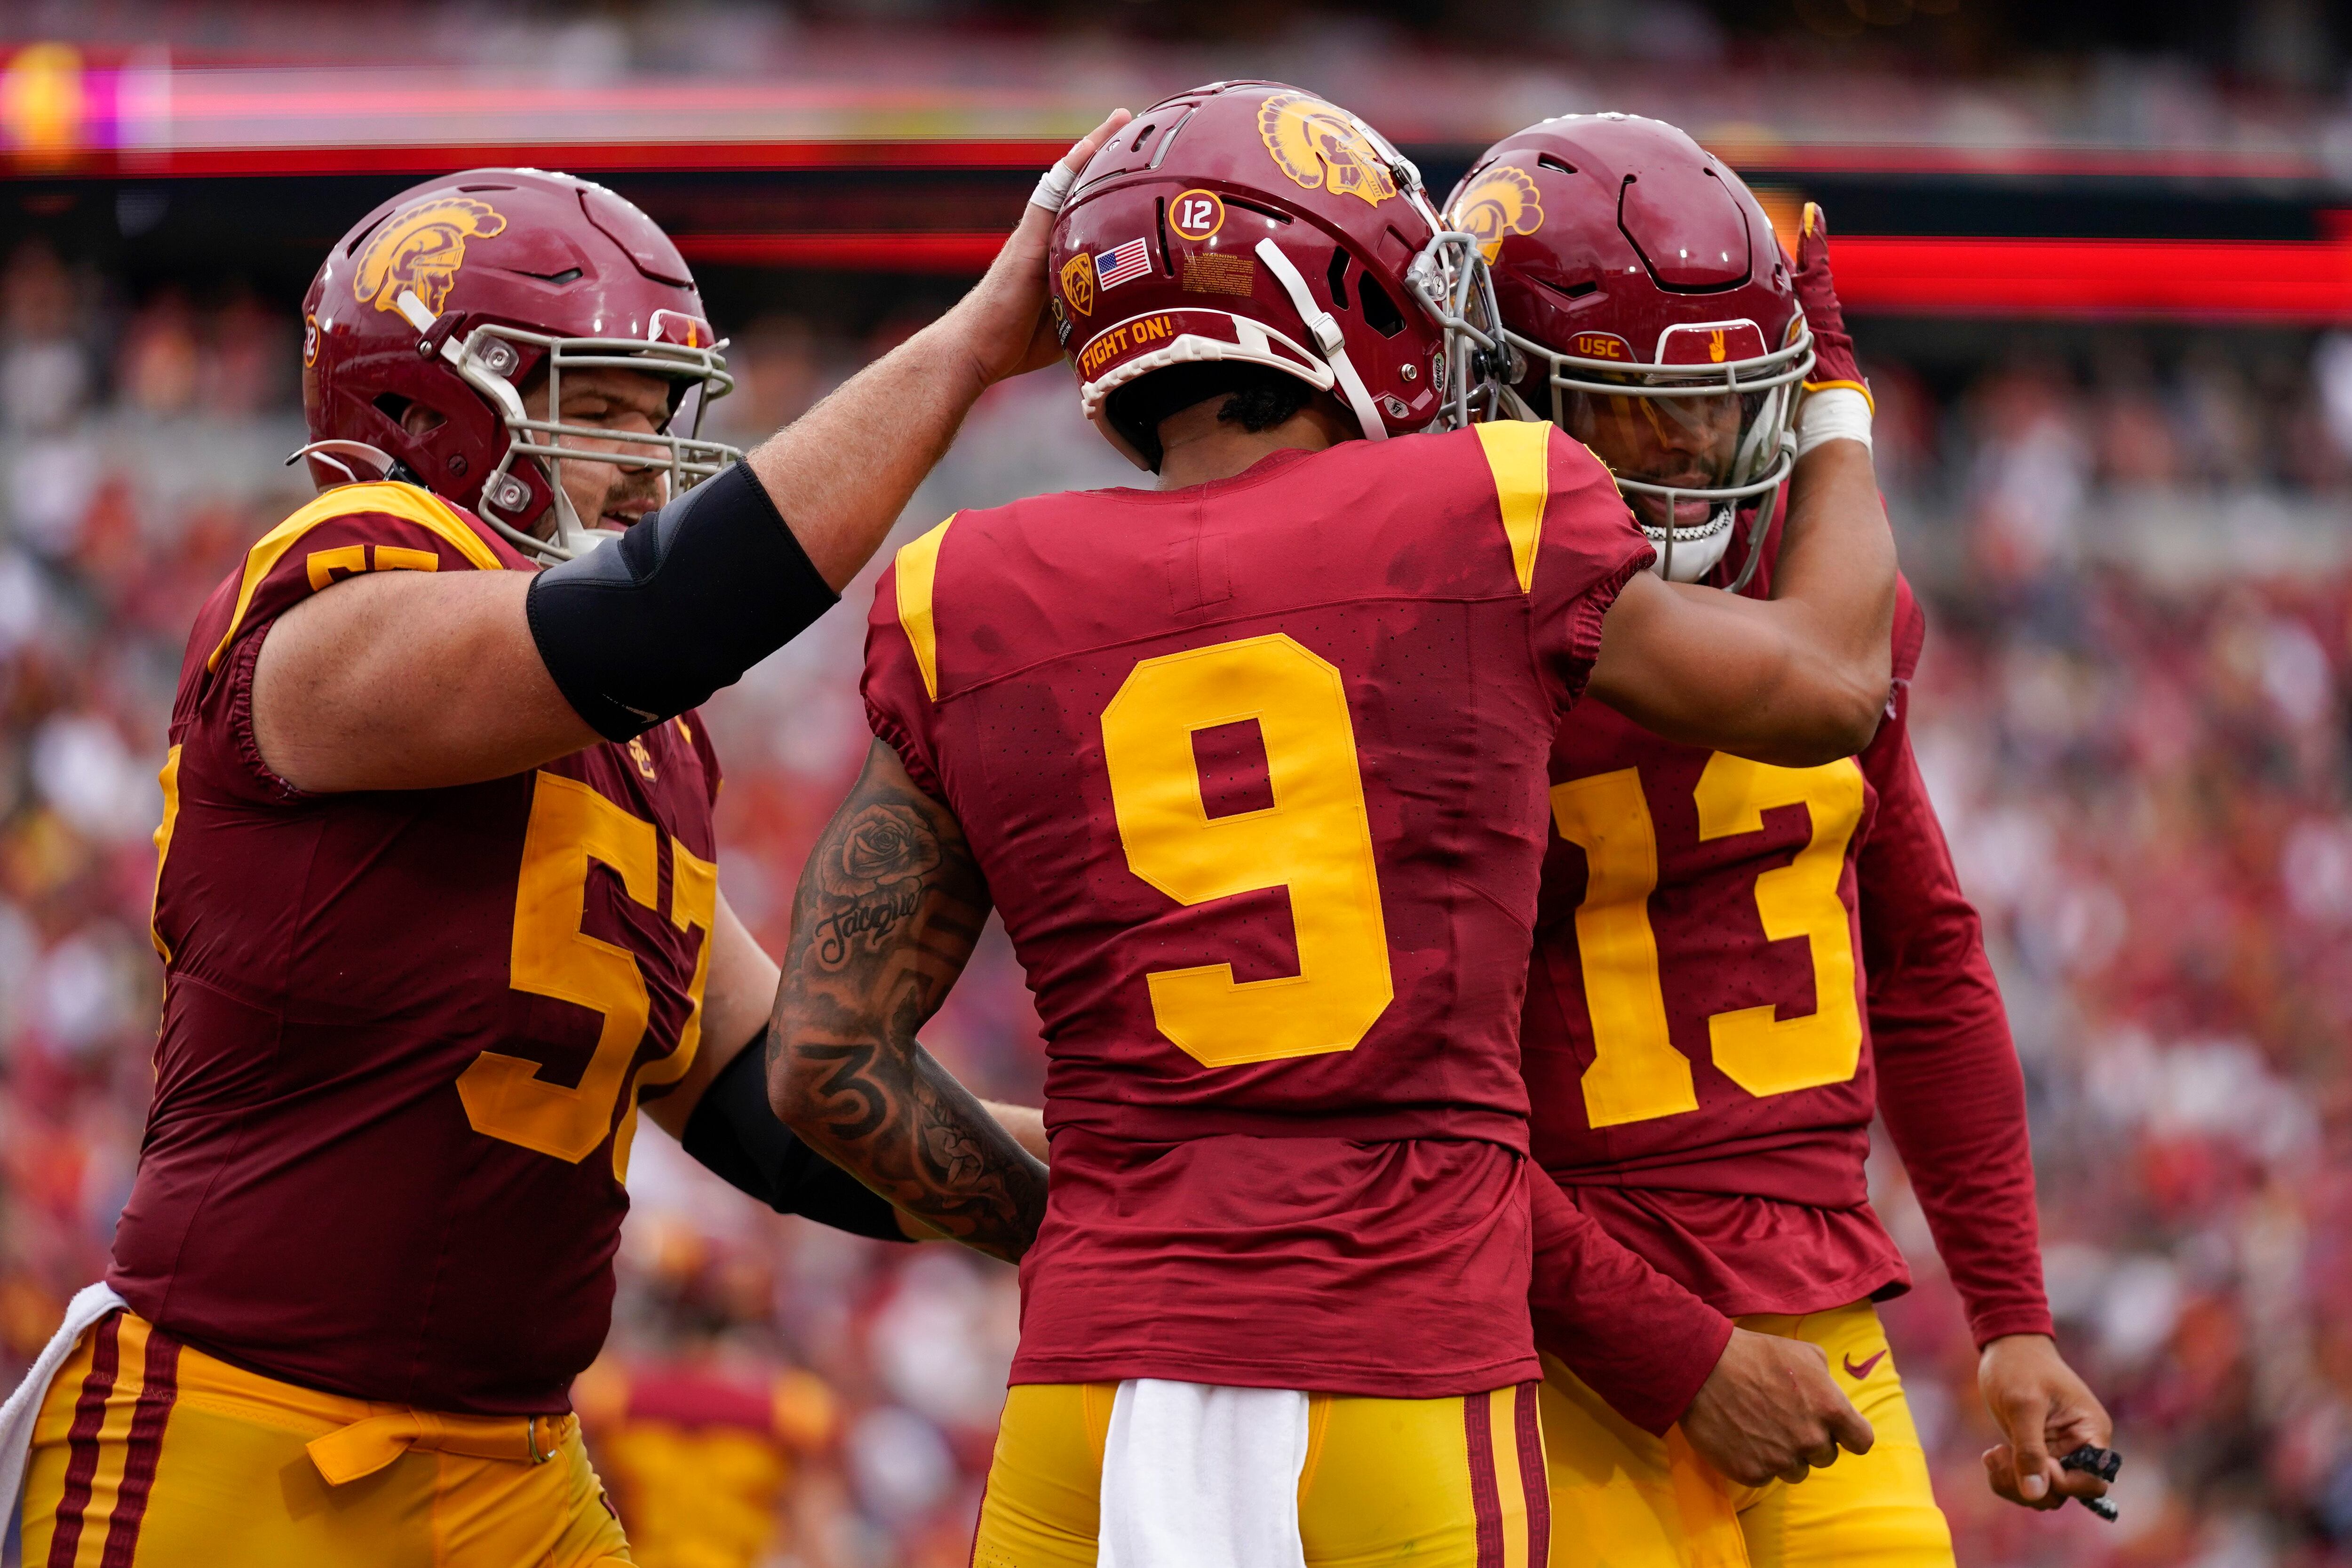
296;169;743;562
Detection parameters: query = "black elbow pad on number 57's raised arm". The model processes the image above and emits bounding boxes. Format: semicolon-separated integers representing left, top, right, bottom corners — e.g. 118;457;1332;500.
527;463;840;740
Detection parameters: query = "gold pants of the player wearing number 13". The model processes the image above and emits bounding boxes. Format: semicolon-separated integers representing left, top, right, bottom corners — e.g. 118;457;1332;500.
1543;1302;1952;1568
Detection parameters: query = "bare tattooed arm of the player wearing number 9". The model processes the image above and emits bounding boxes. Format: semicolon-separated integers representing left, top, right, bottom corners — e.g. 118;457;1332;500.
767;743;1044;1258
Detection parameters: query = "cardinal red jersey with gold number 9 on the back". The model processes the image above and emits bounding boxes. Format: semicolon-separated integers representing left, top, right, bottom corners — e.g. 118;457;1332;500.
866;425;1651;1396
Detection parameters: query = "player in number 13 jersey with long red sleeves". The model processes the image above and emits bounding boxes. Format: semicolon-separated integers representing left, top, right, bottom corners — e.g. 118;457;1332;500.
1449;115;2110;1568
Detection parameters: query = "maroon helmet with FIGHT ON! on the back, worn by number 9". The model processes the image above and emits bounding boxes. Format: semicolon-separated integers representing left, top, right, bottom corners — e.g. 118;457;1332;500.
1049;82;1508;468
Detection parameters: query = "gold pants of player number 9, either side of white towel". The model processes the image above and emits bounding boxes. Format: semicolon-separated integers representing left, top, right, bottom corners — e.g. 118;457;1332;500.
971;1382;1545;1568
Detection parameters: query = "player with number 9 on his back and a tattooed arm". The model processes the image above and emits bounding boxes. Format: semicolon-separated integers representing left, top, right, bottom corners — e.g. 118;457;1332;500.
769;82;1893;1568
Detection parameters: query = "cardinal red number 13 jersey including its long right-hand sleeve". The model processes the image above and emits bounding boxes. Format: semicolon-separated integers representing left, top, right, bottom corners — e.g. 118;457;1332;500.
1522;529;2049;1335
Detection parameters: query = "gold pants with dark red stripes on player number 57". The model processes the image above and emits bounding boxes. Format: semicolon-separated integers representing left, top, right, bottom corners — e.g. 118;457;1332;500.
24;1312;630;1568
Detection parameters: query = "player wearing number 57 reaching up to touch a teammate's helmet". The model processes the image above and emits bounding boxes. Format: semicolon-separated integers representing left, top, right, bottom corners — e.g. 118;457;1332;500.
0;115;1120;1568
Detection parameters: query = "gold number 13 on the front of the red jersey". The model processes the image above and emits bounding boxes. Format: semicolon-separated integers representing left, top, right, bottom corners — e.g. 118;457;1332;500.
1552;752;1863;1126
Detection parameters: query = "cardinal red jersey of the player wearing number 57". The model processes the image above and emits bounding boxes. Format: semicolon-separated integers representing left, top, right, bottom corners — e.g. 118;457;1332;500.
108;484;717;1415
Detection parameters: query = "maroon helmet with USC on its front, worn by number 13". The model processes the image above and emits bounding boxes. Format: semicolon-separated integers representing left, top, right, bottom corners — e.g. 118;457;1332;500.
1446;115;1813;588
